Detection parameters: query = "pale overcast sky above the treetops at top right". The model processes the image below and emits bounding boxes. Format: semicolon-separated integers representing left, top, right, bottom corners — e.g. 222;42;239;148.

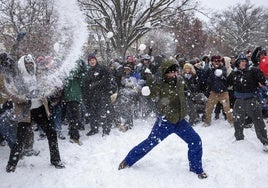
197;0;268;21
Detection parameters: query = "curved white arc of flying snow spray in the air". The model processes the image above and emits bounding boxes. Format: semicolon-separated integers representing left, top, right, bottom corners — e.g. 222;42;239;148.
39;0;88;95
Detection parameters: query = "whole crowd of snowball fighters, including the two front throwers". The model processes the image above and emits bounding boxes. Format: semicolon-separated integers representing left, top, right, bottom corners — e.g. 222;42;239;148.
0;44;268;178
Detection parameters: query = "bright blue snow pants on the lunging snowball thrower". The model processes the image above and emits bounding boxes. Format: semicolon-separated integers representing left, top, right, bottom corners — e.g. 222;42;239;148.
125;116;203;174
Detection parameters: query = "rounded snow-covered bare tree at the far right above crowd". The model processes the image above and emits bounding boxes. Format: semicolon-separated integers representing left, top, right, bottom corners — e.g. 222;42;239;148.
212;3;268;54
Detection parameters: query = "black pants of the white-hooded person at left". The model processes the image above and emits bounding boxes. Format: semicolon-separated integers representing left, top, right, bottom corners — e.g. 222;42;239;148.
8;106;61;166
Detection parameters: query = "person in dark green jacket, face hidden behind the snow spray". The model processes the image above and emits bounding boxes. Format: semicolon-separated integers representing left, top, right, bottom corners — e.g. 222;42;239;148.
63;59;88;145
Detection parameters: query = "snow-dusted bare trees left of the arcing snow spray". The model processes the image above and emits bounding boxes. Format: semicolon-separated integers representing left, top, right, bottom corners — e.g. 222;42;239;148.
0;0;57;58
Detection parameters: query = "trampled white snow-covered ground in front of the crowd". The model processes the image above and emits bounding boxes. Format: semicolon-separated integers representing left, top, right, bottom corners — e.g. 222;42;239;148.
0;114;268;188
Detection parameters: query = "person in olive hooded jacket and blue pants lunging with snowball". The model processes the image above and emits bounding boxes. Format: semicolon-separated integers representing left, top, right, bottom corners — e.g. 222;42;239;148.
118;60;207;179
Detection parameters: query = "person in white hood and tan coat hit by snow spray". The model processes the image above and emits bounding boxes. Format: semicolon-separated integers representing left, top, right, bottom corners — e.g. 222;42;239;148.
2;54;64;172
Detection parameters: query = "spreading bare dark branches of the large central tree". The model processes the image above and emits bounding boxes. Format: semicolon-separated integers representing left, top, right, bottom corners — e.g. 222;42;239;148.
78;0;196;57
